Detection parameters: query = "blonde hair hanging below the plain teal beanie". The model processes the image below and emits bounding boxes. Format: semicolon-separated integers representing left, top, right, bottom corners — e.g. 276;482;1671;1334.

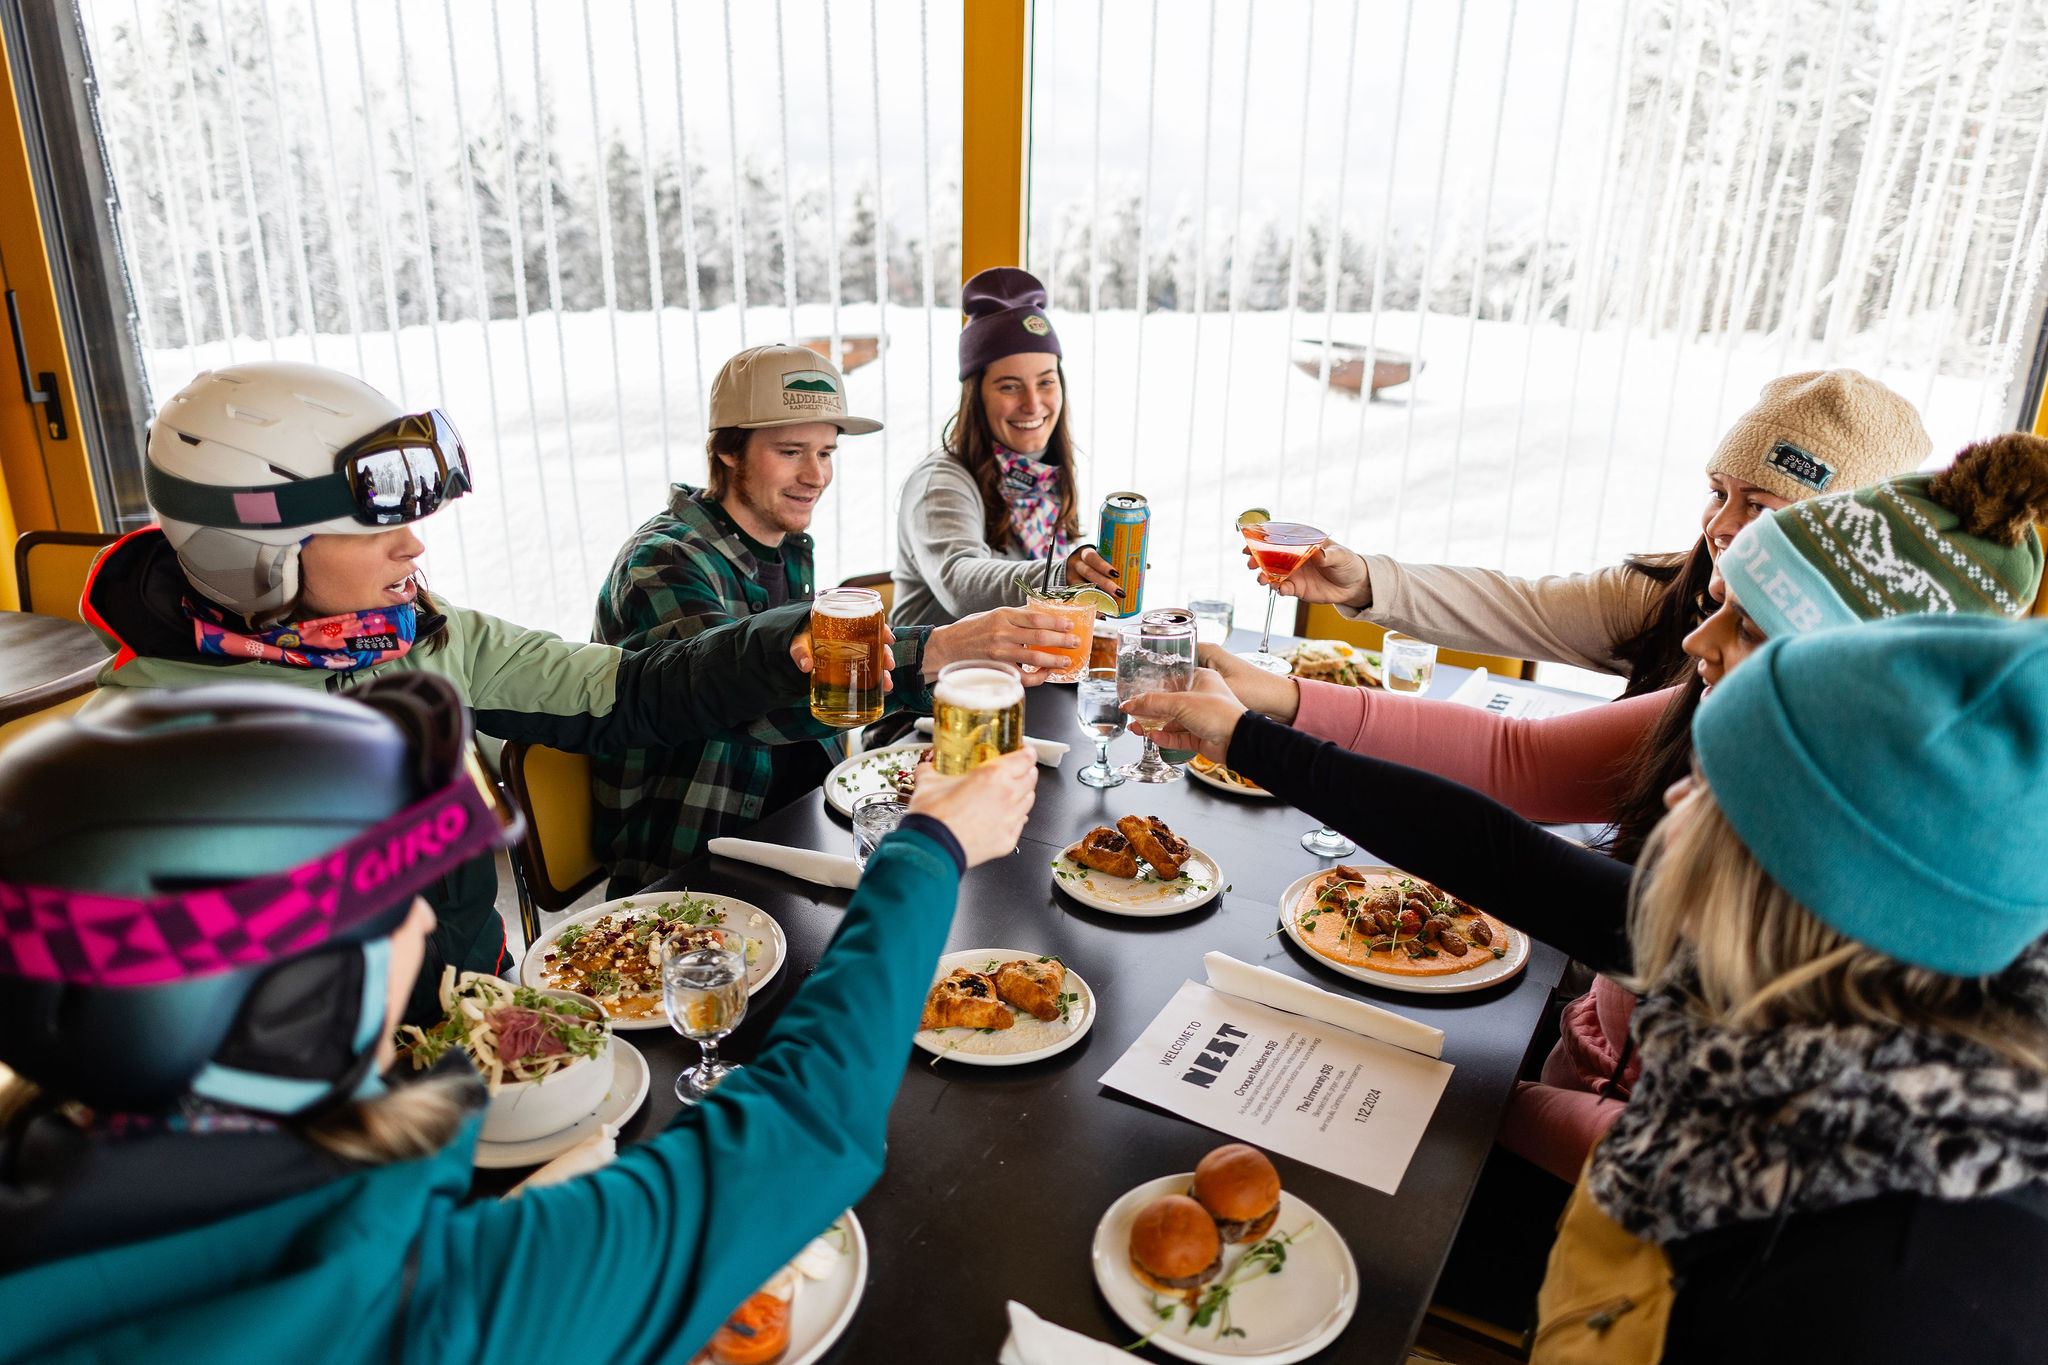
1628;780;2048;1072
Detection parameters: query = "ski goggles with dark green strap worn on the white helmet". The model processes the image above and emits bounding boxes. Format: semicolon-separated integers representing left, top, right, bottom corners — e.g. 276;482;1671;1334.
143;407;475;528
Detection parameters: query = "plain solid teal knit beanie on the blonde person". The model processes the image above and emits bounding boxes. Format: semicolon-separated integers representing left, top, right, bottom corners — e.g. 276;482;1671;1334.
1692;616;2048;976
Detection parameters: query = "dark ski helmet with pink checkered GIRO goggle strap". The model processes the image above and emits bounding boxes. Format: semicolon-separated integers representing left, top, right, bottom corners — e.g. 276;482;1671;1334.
0;671;516;1113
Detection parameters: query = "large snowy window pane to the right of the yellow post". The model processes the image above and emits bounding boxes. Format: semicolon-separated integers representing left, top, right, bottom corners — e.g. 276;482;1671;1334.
1030;0;2048;600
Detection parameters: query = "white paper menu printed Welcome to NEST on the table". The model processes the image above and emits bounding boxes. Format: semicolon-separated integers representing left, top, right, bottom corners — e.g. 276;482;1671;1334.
1102;980;1452;1195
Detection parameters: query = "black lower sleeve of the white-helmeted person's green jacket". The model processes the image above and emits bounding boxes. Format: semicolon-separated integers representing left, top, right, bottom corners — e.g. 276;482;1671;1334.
475;602;811;753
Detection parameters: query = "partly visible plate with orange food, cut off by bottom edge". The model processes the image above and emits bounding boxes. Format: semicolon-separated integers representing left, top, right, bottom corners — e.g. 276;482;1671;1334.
690;1209;868;1365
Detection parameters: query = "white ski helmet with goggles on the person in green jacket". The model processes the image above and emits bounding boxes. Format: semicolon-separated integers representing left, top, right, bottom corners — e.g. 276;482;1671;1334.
143;360;469;620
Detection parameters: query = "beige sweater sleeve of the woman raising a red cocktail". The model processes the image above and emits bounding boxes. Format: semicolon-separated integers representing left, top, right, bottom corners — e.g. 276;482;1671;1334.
1337;555;1663;677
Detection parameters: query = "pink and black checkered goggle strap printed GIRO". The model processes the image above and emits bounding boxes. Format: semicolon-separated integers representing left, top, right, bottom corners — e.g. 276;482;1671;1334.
0;772;518;986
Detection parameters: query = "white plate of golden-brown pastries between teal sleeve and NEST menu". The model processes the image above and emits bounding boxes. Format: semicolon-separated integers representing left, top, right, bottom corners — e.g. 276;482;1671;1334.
911;948;1096;1066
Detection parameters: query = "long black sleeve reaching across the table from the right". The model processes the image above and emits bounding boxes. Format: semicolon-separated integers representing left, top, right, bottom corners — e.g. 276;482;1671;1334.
1229;710;1632;972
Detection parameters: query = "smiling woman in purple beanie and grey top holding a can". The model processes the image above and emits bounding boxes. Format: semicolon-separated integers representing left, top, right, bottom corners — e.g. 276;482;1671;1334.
889;266;1122;626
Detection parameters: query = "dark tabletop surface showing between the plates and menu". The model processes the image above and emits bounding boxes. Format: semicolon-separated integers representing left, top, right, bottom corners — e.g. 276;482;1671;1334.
503;639;1565;1363
